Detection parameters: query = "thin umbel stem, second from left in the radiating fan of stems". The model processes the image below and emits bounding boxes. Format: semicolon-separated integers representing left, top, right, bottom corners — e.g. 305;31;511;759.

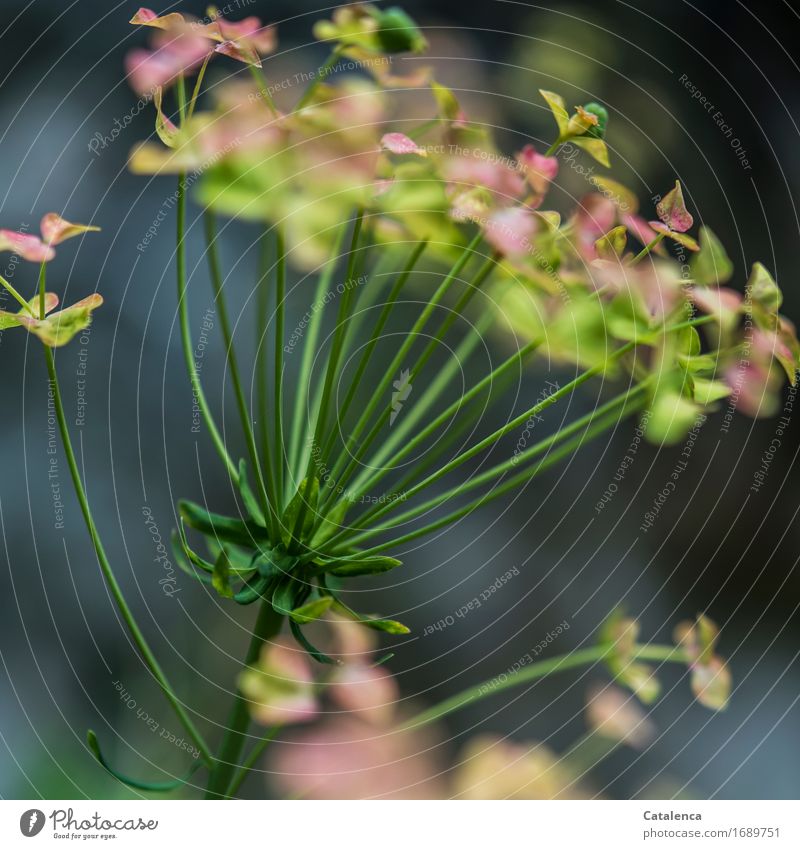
203;210;280;544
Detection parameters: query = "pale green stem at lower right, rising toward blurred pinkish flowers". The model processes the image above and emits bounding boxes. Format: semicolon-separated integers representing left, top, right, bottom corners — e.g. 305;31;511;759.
398;643;688;731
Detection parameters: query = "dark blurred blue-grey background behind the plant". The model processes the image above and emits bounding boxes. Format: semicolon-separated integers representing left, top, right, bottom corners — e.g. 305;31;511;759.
0;0;800;798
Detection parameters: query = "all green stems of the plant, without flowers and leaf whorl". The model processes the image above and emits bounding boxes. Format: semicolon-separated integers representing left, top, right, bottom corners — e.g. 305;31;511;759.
18;57;706;798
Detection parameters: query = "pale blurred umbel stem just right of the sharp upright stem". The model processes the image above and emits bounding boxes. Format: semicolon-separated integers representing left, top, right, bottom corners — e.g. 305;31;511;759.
289;221;350;478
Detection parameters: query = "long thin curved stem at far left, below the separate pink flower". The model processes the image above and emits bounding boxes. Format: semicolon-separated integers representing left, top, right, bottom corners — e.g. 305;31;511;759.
43;346;214;765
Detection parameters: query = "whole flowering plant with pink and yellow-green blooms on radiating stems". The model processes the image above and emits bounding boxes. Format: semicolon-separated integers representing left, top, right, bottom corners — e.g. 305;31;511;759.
0;4;800;798
